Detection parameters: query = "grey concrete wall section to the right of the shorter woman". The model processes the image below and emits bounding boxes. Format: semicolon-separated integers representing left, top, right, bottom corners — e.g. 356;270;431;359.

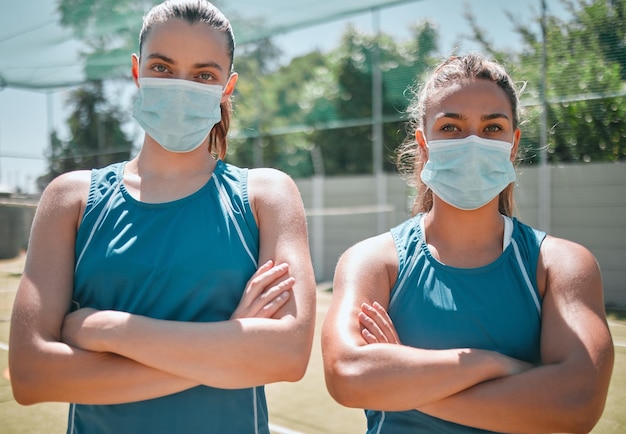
516;164;626;310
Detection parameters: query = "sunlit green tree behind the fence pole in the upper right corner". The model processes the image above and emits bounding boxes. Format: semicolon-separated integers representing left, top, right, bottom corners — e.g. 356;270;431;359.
460;0;626;162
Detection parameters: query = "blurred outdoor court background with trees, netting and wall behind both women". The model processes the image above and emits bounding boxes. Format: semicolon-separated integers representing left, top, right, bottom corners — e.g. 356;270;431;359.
0;0;626;434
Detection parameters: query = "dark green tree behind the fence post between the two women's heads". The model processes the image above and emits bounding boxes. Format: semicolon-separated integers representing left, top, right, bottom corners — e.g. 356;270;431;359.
306;22;437;175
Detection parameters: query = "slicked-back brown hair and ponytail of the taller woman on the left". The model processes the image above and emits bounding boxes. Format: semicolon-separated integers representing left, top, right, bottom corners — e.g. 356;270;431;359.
139;0;235;159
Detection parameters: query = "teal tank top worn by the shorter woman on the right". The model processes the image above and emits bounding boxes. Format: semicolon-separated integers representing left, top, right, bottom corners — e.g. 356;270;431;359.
366;215;545;434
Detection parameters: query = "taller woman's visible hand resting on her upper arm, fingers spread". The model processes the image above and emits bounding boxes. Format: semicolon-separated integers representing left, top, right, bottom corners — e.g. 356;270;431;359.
230;261;296;319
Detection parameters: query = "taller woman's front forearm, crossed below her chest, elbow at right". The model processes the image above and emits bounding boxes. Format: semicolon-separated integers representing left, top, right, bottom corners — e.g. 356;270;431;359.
89;312;310;388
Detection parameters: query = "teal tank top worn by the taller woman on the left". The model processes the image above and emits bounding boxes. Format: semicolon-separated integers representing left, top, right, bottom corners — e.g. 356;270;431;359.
67;161;269;434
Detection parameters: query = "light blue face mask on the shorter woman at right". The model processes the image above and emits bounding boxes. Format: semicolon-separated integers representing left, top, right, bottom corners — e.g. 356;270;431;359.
421;136;515;210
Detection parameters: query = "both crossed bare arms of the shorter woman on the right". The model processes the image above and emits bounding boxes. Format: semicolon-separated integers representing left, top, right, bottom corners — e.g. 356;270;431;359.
323;235;613;432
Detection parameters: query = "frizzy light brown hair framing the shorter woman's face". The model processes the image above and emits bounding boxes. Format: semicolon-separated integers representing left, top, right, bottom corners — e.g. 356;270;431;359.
397;54;520;216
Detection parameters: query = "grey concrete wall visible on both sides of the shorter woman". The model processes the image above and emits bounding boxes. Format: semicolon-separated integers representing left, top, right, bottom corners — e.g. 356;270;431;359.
296;163;626;310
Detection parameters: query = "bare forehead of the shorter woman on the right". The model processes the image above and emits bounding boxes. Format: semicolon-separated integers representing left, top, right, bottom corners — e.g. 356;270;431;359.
424;79;513;122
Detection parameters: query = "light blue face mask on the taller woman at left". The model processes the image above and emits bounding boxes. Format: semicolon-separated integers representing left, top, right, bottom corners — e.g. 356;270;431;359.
133;78;222;152
